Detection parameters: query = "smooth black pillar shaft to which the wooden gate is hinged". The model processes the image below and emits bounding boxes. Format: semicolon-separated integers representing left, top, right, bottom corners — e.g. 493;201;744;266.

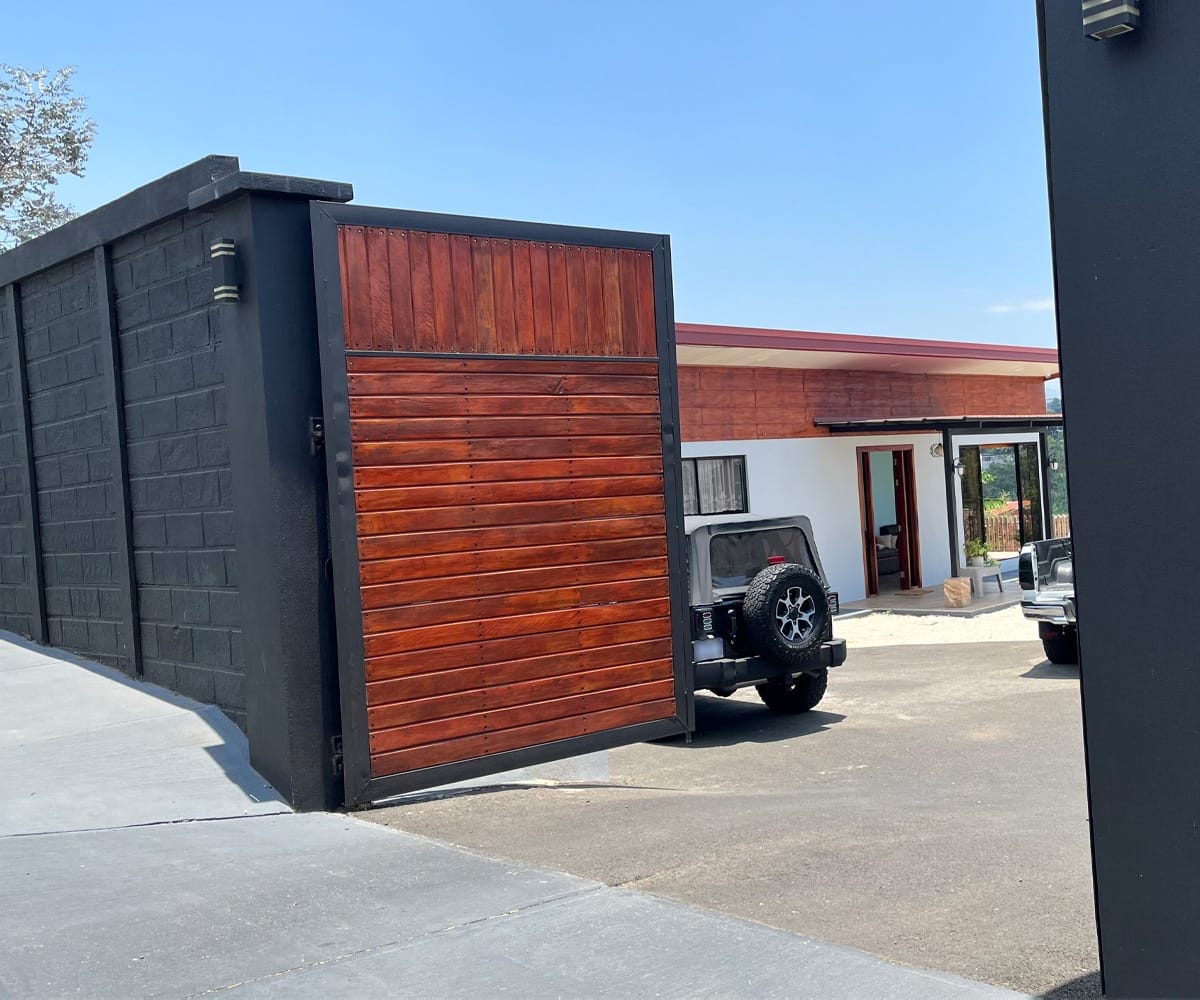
217;196;342;809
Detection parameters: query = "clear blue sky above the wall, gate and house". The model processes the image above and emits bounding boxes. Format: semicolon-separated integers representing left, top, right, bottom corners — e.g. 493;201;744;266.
11;0;1055;347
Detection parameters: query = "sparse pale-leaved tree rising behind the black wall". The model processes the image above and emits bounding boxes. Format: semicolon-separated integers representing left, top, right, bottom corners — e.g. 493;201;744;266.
0;64;96;253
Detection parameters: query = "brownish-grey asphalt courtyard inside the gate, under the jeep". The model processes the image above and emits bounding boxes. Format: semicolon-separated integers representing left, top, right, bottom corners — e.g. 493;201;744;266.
361;629;1099;998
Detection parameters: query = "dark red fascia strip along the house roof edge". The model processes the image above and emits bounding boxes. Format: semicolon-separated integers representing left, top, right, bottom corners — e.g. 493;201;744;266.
676;323;1058;365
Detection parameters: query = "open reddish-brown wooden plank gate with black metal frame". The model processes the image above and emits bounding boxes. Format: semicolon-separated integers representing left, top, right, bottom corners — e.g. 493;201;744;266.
312;203;692;806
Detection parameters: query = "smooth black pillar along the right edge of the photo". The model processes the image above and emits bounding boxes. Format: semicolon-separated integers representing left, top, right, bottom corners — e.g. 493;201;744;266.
1038;0;1200;998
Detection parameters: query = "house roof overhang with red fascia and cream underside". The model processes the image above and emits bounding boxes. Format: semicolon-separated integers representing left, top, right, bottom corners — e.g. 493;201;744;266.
676;323;1058;379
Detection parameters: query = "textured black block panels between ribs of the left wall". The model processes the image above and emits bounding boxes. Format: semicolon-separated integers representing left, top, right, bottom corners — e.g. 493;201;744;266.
0;211;246;727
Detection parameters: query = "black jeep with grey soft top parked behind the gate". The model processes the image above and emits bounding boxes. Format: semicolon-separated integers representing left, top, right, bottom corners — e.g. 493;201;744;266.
686;514;846;712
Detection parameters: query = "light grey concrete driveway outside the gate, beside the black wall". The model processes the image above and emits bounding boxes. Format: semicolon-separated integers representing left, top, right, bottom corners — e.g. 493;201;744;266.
0;633;1018;1000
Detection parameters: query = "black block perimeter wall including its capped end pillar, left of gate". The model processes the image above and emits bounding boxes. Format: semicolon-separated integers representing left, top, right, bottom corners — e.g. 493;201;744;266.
0;156;353;809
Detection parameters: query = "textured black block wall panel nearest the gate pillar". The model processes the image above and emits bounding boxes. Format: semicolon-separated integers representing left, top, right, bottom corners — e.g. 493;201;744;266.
112;211;246;726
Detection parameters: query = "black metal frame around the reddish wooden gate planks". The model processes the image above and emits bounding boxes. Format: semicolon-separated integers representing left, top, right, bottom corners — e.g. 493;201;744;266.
310;202;695;808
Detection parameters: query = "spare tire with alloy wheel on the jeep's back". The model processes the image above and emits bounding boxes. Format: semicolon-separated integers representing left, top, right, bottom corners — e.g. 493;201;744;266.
742;563;829;664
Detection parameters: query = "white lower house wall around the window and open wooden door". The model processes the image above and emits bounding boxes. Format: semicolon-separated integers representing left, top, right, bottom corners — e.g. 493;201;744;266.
683;435;950;601
